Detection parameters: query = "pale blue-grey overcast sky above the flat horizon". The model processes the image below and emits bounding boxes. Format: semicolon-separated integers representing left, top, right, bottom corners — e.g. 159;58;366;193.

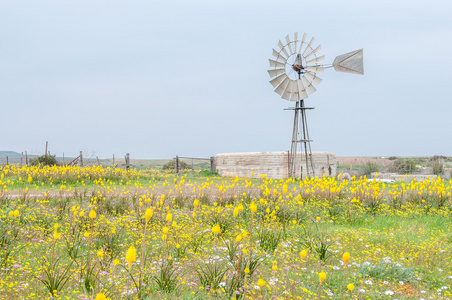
0;0;452;158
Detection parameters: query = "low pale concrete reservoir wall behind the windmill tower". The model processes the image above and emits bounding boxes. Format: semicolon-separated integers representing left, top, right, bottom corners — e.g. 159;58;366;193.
213;151;337;179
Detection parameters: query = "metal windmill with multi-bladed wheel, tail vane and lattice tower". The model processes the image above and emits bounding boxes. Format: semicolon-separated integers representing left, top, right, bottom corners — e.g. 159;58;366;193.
268;32;364;178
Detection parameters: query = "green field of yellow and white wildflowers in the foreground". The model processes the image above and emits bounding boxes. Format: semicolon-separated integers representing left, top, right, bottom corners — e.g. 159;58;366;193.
0;166;452;299
